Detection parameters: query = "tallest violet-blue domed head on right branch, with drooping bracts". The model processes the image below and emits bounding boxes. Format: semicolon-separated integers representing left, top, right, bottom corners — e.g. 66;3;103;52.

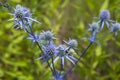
99;10;114;29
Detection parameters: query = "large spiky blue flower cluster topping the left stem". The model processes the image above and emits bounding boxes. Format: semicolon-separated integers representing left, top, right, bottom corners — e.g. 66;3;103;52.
10;5;39;29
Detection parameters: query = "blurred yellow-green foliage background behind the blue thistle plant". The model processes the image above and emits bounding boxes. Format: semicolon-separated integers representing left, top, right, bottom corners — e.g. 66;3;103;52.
0;0;120;80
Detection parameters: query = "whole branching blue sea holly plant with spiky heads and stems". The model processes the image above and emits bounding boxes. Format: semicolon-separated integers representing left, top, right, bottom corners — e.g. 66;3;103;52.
0;2;120;80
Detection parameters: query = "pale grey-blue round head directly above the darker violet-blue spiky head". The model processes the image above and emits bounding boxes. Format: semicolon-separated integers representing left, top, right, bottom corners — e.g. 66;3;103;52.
41;31;55;41
